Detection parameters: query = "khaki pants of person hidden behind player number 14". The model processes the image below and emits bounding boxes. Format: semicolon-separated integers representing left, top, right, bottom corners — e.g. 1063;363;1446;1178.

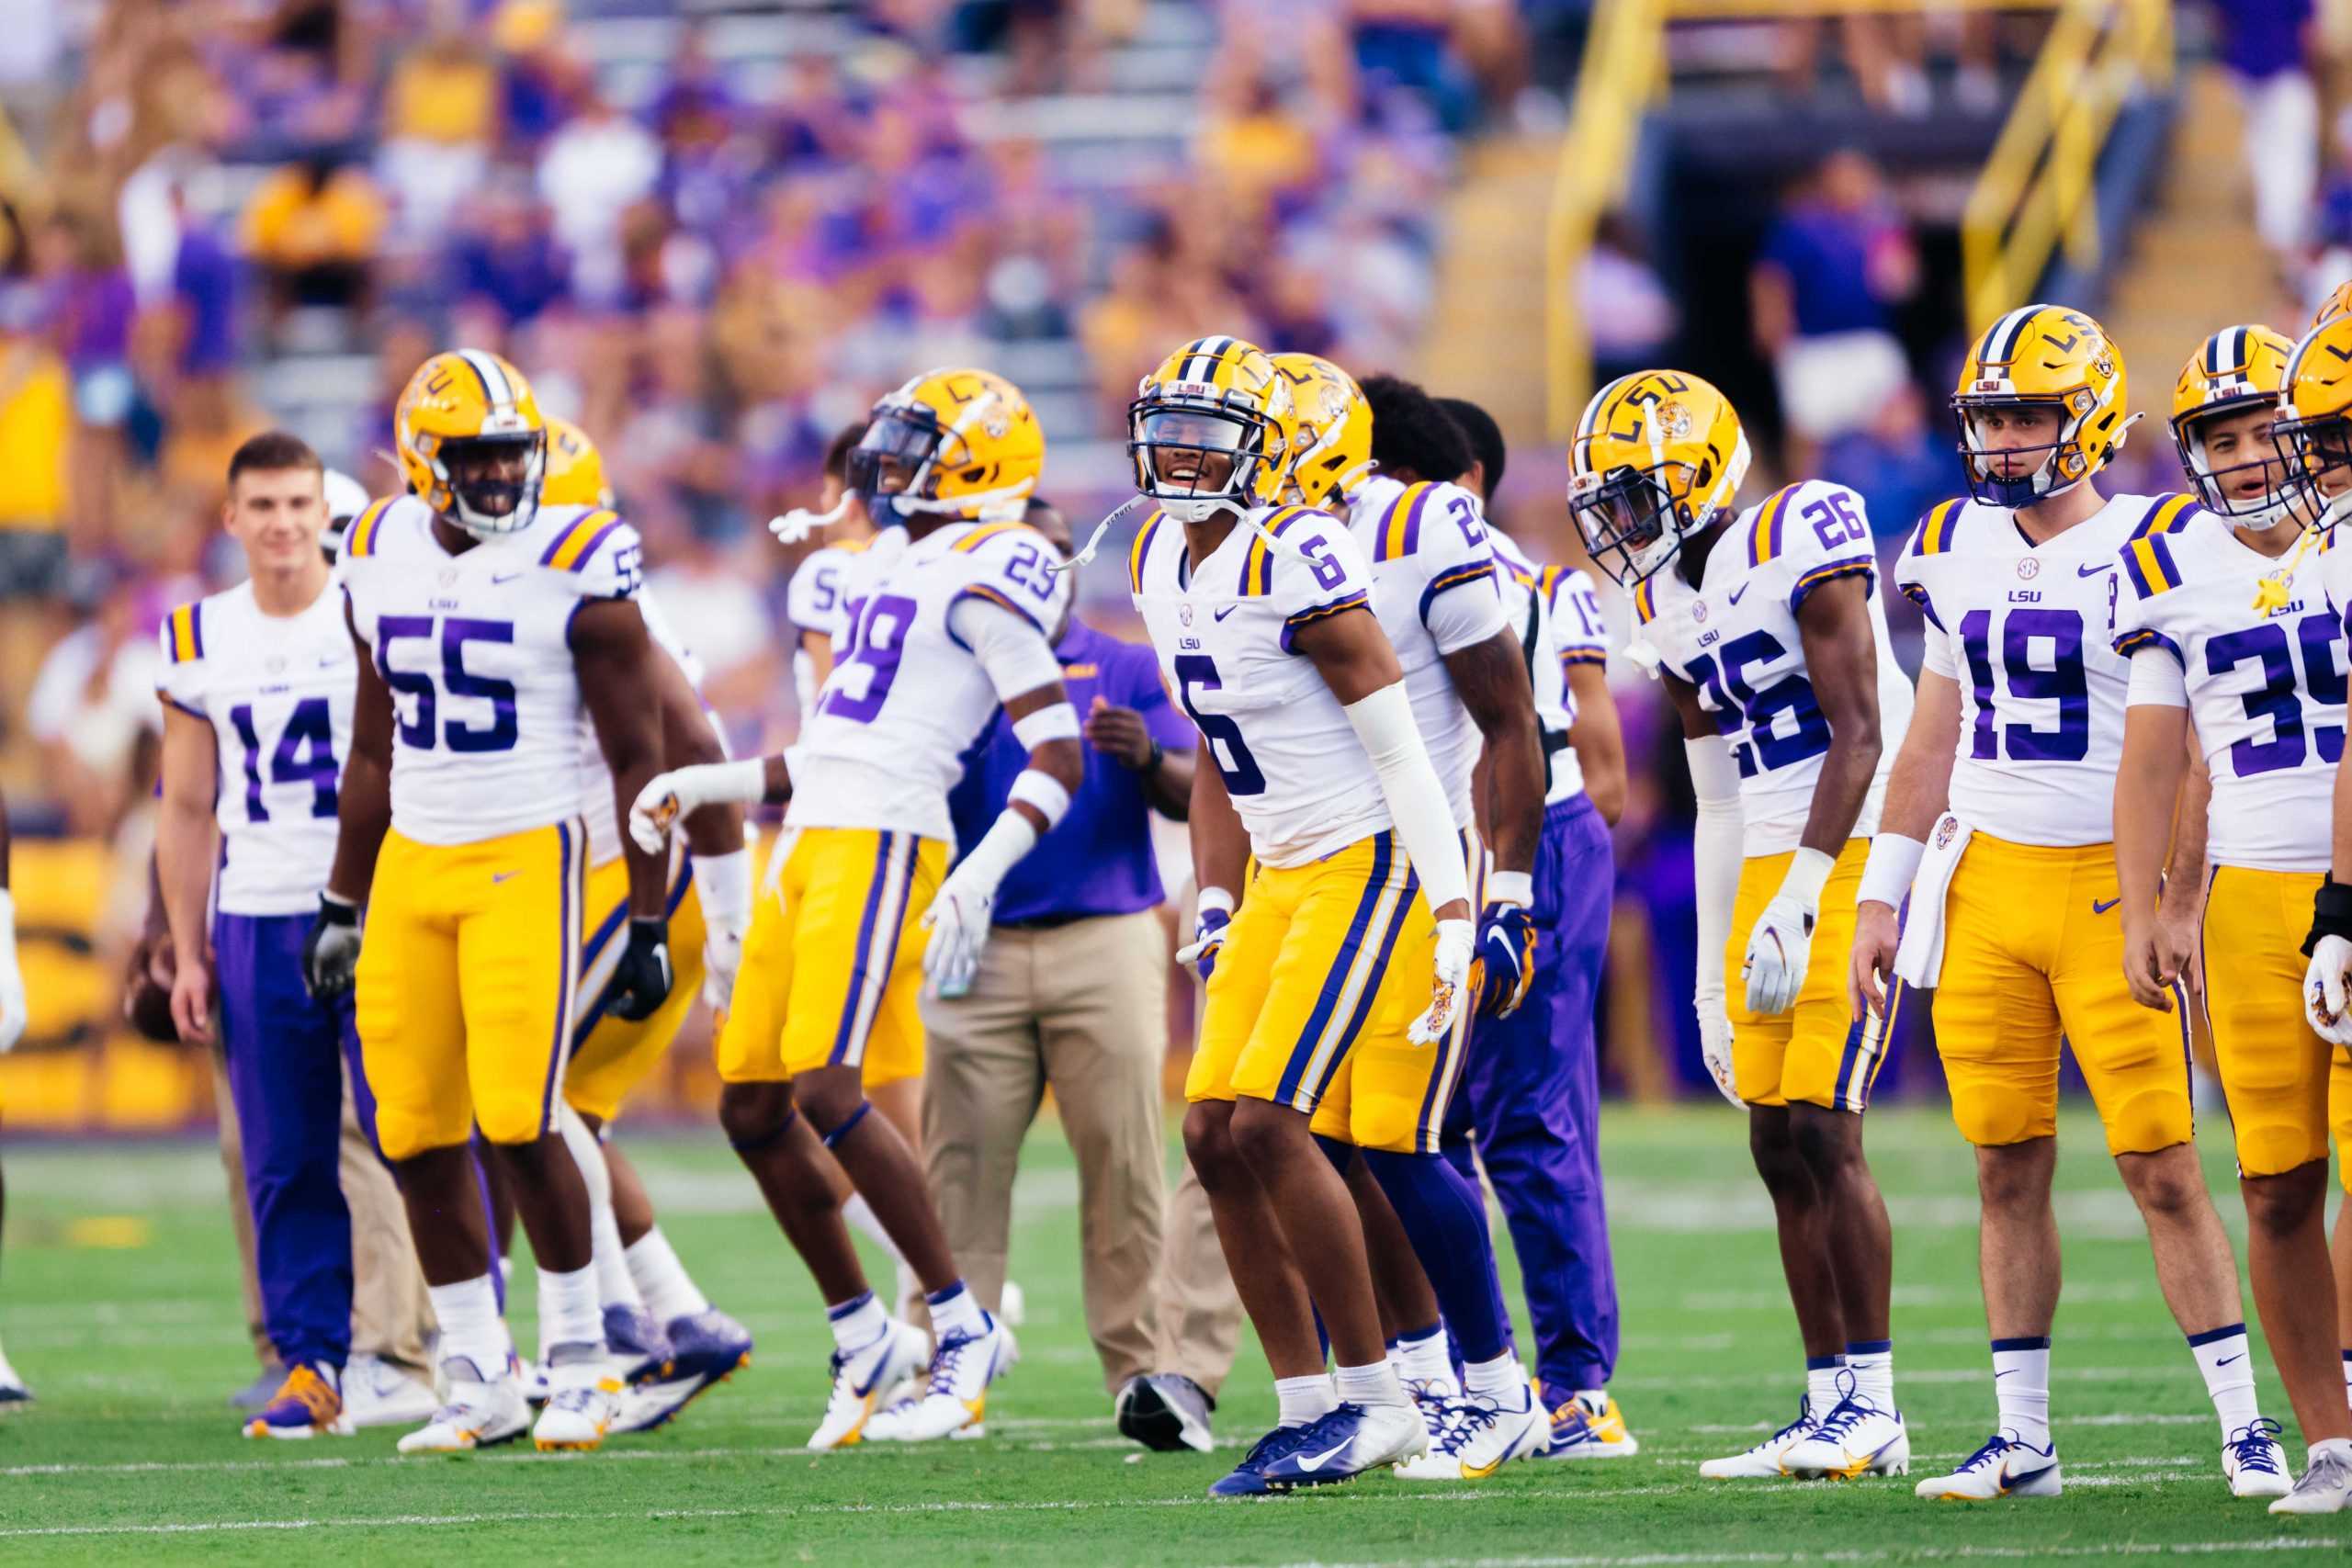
211;1051;435;1378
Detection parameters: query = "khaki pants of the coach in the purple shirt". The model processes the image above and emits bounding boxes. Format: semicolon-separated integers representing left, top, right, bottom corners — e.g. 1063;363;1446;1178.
922;909;1167;1392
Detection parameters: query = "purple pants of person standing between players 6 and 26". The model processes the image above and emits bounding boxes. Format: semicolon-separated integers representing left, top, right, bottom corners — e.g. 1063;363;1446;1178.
1452;795;1618;1404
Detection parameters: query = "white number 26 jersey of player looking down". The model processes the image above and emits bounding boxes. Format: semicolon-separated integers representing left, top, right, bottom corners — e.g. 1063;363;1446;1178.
1633;479;1912;856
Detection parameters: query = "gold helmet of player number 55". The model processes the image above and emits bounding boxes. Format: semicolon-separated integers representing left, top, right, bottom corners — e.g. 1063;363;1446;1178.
393;348;548;538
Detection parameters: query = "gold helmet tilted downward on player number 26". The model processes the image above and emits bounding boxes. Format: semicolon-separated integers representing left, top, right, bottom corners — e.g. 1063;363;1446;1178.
1569;369;1747;588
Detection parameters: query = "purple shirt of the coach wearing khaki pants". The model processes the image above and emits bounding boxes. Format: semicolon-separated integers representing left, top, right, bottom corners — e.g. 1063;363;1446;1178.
948;618;1197;926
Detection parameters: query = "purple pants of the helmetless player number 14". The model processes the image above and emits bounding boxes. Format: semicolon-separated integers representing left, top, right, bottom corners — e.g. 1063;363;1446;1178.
211;915;374;1366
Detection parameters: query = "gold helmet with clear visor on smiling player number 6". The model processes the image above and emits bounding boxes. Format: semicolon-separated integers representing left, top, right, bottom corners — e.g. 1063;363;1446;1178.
1126;336;1298;522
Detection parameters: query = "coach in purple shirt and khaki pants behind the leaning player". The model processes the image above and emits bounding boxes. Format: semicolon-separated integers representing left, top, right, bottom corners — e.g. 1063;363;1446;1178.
922;501;1194;1419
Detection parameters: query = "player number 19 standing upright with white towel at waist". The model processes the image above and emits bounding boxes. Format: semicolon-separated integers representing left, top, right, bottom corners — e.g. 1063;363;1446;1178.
1849;306;2286;1500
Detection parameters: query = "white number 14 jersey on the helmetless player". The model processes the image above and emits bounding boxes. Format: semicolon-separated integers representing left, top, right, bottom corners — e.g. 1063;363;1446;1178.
158;581;360;915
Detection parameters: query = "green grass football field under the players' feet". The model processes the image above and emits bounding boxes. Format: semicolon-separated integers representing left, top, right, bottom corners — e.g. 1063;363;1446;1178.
0;1107;2352;1568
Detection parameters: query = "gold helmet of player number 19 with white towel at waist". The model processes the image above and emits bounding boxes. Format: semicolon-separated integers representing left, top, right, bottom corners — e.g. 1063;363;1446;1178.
1952;306;2131;510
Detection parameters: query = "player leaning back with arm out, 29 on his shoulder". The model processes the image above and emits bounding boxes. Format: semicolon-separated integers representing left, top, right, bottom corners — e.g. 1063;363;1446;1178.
630;369;1082;1448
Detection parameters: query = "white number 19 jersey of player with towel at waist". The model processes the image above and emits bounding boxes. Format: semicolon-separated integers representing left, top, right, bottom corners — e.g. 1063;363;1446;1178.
1889;496;2192;846
